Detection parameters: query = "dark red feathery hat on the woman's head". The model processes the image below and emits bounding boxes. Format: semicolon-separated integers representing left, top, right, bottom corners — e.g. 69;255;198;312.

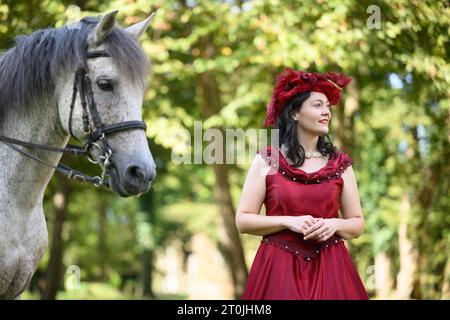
264;68;352;127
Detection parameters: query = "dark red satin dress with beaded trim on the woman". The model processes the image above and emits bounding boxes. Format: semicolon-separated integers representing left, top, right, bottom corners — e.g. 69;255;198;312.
243;147;368;300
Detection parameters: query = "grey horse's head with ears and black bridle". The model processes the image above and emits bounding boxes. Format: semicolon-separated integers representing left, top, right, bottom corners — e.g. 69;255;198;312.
56;11;156;197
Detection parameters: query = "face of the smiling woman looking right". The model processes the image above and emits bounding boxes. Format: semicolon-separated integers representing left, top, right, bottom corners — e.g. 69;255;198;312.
293;91;331;135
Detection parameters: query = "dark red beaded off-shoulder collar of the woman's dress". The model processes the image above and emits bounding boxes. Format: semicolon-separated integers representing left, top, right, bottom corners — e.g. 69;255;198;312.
258;146;353;184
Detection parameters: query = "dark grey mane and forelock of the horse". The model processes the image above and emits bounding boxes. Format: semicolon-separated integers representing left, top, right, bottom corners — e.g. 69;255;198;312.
0;17;150;128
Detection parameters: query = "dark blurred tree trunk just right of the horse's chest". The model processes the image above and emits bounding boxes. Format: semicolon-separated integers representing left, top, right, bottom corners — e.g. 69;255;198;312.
42;174;71;300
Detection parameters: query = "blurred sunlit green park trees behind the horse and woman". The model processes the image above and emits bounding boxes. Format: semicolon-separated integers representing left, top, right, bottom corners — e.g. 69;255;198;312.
0;0;450;299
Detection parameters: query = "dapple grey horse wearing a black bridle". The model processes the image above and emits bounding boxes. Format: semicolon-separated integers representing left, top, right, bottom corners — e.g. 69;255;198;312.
0;11;156;299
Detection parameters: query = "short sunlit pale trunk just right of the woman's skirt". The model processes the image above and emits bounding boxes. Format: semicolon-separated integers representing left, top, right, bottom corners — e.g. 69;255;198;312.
375;252;393;300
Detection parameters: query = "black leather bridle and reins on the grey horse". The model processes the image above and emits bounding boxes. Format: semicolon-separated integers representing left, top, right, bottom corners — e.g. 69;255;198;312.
0;50;147;187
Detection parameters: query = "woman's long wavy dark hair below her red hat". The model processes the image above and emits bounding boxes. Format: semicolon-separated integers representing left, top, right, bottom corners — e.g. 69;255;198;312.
275;91;337;167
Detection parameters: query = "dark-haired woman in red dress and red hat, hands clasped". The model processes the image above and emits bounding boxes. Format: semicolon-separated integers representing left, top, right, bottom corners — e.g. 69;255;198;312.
236;69;368;300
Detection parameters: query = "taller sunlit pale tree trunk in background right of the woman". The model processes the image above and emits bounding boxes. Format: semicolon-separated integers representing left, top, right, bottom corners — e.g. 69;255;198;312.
396;193;418;299
